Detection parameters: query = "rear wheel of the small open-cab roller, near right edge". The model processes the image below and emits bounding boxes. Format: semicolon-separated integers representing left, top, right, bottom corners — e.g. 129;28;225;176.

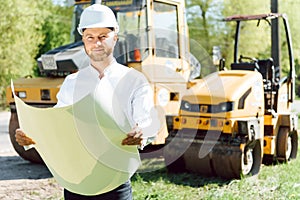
276;127;298;162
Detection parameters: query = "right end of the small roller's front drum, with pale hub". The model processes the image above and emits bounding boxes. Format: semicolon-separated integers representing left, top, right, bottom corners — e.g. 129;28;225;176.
241;140;262;176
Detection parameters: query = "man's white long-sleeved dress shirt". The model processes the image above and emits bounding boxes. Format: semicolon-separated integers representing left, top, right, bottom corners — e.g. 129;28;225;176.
55;60;159;138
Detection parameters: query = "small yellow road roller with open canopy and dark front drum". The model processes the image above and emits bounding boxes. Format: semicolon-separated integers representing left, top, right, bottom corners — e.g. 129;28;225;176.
164;13;298;179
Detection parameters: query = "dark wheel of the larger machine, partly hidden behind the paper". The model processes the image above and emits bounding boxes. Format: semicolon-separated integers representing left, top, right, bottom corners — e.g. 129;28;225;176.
9;112;44;164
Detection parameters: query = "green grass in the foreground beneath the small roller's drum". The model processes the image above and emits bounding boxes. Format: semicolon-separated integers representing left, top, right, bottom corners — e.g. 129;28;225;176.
132;145;300;200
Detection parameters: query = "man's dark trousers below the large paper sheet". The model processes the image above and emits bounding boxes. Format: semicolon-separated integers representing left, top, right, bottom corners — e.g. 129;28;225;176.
64;181;132;200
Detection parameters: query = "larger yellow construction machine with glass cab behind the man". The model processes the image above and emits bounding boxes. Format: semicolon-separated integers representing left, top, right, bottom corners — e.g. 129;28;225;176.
6;0;200;163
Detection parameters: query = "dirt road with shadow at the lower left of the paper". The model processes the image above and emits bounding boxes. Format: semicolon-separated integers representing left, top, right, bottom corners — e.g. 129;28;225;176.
0;112;63;200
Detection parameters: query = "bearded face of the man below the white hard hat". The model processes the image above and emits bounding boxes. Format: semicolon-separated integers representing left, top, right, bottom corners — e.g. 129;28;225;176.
82;28;117;61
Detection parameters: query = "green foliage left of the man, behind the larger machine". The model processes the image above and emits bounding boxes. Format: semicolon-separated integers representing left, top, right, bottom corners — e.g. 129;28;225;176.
0;0;71;107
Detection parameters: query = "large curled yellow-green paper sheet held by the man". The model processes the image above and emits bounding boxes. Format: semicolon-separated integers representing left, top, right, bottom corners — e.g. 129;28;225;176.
15;89;140;195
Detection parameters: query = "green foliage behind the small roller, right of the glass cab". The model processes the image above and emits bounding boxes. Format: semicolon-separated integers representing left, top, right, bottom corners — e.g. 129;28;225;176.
186;0;300;95
